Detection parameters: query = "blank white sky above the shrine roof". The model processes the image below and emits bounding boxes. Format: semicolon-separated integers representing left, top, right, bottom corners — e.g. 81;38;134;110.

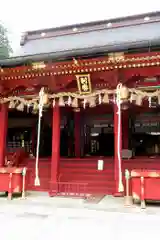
0;0;160;51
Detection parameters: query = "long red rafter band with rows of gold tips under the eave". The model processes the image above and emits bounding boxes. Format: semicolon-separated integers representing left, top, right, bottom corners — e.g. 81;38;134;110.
0;52;160;77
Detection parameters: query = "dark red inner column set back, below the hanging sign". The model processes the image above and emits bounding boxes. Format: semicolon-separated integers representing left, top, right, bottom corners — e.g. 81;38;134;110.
74;109;81;158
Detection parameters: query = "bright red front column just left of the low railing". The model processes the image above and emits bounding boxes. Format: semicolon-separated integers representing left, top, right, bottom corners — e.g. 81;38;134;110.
50;104;60;196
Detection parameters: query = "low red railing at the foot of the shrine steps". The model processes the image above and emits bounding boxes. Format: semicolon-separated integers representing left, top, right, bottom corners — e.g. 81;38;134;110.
50;182;89;198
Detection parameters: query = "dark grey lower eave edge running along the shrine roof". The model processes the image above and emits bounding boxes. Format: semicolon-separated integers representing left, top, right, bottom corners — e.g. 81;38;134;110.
0;38;160;67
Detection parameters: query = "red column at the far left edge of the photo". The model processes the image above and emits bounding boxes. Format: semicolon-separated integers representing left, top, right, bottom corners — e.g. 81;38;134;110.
0;104;8;167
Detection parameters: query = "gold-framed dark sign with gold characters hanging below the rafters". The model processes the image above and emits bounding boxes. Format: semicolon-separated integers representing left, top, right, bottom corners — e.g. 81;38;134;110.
76;74;92;94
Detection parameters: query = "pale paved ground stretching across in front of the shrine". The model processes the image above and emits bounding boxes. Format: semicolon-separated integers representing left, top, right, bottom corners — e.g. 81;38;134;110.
0;194;160;240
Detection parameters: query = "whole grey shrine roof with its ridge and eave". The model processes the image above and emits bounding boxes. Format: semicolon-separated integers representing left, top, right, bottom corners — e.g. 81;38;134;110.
0;12;160;66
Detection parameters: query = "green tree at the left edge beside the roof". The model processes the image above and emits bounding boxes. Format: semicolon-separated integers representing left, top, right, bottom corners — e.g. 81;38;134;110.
0;23;12;59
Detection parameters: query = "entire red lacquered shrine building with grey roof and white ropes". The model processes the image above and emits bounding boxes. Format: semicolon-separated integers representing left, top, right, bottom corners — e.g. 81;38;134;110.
0;12;160;199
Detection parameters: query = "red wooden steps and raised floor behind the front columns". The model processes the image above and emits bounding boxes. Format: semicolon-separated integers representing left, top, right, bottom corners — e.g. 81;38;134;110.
20;157;160;195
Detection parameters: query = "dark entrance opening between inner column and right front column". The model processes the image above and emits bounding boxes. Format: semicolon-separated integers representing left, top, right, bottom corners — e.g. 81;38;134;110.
83;105;114;157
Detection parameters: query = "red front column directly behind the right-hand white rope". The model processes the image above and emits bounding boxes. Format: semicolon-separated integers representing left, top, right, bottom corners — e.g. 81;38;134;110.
114;104;122;196
